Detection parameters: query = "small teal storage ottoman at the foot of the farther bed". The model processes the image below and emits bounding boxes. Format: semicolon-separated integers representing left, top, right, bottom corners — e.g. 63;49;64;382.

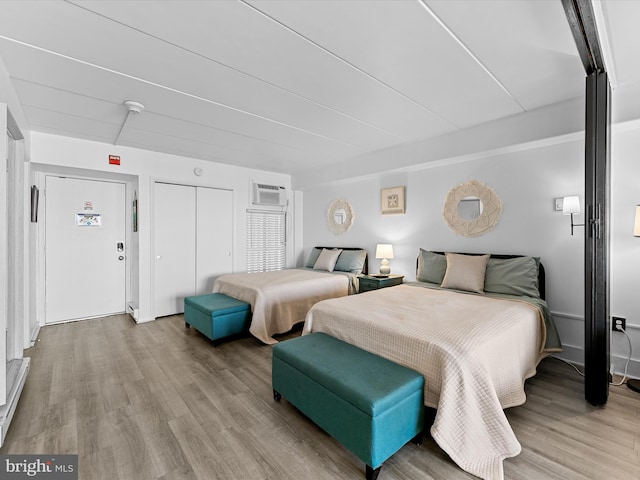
184;293;251;342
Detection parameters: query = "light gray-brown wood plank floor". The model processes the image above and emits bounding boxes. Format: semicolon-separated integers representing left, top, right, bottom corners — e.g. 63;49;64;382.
0;315;640;480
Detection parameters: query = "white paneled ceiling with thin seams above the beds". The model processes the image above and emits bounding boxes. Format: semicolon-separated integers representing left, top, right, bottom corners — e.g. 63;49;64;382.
0;0;640;174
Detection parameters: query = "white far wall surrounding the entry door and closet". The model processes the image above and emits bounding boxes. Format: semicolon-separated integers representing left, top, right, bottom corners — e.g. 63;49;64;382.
31;132;294;321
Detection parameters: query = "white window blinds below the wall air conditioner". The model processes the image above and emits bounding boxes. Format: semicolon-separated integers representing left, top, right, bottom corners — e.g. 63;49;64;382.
247;210;286;273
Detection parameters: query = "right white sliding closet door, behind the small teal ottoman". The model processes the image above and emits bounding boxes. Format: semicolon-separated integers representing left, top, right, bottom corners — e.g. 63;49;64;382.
196;187;233;295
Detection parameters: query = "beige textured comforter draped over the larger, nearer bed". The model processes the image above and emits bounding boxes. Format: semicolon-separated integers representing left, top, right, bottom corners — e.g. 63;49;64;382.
303;282;560;479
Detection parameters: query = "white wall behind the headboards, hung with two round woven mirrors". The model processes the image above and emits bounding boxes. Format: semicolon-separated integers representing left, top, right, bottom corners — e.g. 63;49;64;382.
298;132;640;382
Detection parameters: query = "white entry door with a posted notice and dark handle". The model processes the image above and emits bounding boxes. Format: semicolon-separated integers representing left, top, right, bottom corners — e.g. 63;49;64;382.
45;176;126;323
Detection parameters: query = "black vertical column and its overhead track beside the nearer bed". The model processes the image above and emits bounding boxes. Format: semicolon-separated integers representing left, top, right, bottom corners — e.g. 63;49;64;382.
561;0;610;405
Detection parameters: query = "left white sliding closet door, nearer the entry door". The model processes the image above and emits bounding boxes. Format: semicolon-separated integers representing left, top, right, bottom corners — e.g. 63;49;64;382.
153;183;196;317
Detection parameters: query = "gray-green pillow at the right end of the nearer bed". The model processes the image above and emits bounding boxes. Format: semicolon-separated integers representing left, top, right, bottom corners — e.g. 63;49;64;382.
484;257;540;297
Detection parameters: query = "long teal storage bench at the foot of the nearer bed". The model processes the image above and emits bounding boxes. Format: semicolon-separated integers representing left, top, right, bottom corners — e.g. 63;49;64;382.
271;333;424;480
